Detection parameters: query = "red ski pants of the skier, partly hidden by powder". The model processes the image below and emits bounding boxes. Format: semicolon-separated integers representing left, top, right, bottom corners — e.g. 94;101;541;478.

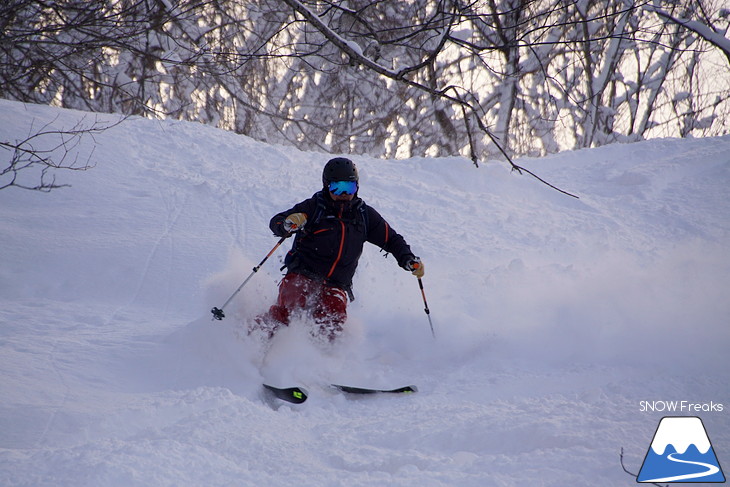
268;272;347;340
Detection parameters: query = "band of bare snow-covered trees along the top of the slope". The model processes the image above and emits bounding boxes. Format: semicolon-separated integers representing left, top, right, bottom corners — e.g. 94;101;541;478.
0;0;730;164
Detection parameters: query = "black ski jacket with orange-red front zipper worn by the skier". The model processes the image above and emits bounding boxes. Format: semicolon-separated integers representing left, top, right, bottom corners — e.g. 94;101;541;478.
269;191;414;291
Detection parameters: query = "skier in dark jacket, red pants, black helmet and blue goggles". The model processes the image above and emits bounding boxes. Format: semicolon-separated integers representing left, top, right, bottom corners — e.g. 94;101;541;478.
251;157;424;342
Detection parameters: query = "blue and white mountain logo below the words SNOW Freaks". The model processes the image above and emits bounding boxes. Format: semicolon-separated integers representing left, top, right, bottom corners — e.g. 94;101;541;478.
636;416;725;483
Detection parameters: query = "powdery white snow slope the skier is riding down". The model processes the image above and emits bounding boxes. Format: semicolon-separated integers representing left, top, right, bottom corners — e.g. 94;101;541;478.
0;101;730;487
